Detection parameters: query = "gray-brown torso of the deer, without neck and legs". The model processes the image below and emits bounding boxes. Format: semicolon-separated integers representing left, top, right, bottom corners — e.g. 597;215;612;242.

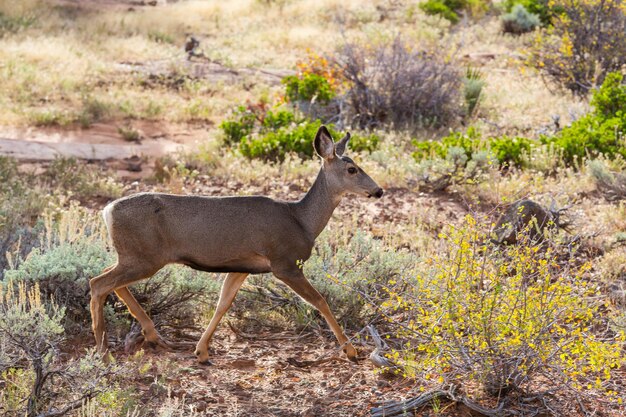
105;193;313;273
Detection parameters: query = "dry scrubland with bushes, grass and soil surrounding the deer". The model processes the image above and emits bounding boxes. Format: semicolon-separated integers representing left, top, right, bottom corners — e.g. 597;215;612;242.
0;0;626;417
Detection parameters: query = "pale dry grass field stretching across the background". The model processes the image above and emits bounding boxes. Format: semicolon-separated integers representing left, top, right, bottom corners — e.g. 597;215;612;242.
0;0;585;132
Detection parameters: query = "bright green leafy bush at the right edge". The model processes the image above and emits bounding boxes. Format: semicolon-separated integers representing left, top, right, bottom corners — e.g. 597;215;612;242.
542;73;626;164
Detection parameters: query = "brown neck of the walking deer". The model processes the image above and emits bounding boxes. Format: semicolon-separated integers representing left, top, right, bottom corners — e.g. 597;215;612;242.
295;170;342;237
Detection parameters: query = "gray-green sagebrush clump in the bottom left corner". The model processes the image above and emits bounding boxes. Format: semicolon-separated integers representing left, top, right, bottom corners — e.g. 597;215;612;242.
0;281;122;417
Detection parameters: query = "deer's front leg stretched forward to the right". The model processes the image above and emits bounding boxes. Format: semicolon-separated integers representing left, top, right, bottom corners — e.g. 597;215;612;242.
274;265;357;362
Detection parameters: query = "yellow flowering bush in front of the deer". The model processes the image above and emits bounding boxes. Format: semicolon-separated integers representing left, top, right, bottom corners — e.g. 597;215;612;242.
382;216;624;408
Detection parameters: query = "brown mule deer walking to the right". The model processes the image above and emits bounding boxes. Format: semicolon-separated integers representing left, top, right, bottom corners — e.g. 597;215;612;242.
89;126;383;363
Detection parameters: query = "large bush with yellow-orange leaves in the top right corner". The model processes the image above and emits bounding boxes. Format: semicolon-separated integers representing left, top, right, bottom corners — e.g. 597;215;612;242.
530;0;626;95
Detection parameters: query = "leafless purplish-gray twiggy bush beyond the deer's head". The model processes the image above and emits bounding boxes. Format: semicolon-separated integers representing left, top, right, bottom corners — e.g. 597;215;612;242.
335;37;462;129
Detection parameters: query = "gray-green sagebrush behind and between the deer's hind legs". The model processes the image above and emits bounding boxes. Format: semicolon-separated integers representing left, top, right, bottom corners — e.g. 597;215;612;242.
3;206;218;334
